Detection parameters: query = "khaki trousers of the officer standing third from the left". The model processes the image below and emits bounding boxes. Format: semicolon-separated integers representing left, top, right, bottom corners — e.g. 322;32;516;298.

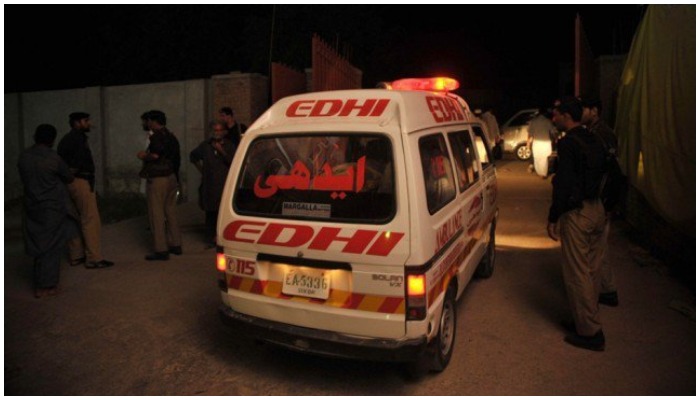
146;174;182;252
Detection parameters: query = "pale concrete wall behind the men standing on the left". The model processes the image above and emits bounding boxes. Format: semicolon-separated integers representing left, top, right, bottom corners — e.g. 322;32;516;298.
5;73;268;201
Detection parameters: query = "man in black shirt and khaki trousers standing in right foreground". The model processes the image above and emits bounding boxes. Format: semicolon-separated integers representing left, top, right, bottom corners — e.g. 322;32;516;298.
547;97;605;351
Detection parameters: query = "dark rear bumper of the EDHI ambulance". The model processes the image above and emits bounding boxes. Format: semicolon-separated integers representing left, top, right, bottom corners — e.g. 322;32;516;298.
219;305;428;362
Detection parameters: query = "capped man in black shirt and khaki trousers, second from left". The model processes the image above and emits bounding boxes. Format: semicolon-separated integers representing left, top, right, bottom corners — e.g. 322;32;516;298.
58;112;114;269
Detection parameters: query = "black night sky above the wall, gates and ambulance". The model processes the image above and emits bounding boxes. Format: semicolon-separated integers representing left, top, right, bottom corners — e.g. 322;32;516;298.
4;5;645;112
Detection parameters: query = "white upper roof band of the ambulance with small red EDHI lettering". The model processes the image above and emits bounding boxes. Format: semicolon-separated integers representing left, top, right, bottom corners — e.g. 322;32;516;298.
249;89;474;134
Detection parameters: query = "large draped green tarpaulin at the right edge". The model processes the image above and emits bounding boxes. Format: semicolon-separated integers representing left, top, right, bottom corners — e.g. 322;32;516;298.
615;5;696;237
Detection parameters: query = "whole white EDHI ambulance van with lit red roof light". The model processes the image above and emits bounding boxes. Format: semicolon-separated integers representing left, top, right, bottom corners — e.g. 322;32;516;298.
217;78;498;371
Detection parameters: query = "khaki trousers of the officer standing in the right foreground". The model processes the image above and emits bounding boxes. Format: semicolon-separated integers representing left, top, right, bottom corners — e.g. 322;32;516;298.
559;199;606;336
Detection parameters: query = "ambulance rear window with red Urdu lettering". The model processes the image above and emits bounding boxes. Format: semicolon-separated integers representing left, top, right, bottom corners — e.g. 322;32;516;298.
233;134;396;223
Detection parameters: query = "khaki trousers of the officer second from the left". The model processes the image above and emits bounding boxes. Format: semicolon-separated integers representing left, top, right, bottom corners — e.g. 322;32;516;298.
68;178;102;262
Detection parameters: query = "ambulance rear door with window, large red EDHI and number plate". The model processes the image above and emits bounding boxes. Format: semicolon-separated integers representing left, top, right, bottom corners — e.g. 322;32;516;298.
220;123;410;338
